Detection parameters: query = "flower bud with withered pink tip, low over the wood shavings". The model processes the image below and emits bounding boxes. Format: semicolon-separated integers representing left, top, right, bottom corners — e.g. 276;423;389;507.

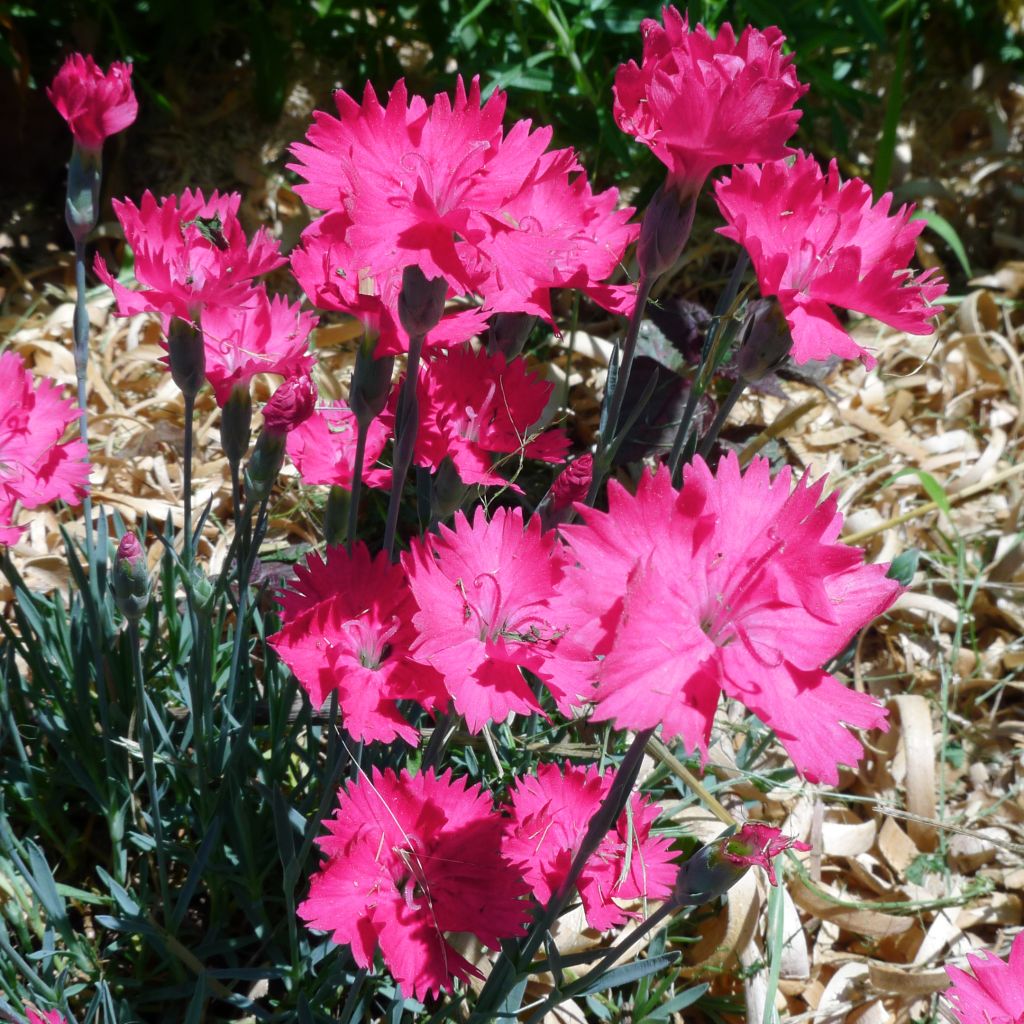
672;821;810;906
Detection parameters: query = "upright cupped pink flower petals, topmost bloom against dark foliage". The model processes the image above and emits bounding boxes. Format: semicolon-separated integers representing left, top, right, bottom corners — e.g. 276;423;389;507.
614;7;808;196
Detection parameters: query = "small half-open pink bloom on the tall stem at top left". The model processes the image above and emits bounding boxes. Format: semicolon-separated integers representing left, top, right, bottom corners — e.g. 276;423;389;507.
46;53;138;151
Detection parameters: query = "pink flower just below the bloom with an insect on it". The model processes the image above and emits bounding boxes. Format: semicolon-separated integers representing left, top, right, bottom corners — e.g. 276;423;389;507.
197;288;316;407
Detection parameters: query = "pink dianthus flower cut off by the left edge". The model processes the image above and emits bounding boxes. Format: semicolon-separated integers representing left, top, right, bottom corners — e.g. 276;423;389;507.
0;352;89;544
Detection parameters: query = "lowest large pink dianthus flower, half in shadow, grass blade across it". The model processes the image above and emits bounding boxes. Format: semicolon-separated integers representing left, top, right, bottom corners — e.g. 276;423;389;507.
299;769;529;999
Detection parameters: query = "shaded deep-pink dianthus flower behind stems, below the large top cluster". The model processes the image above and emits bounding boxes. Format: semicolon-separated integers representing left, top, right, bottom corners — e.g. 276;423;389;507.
383;345;568;486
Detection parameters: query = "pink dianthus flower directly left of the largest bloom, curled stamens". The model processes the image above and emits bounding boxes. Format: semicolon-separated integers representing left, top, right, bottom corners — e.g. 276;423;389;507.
402;507;571;732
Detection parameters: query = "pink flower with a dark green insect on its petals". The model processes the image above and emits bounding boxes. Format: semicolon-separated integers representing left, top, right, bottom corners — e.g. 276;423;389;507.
93;188;285;321
